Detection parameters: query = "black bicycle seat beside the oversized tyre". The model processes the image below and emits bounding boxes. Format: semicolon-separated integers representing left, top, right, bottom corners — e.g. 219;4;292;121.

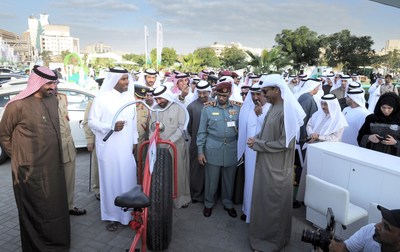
114;185;150;208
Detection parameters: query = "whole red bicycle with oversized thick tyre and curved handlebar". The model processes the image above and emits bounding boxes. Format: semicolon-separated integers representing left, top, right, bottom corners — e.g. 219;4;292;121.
103;101;189;252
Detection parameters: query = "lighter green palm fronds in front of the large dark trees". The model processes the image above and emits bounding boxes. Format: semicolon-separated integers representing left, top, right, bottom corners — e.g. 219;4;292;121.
246;47;291;74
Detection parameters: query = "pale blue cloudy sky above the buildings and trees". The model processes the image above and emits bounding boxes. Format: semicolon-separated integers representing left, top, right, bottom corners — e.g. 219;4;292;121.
0;0;400;54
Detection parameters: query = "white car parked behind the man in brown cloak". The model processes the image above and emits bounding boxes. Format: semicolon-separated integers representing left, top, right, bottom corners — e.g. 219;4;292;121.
0;79;95;164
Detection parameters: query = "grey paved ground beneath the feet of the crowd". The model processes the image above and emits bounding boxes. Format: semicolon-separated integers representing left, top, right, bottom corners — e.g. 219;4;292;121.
0;150;312;252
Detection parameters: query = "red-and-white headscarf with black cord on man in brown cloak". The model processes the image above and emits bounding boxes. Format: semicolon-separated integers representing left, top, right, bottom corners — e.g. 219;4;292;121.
6;66;58;106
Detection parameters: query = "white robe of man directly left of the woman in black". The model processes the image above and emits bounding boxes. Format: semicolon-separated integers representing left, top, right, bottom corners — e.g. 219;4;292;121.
342;107;371;146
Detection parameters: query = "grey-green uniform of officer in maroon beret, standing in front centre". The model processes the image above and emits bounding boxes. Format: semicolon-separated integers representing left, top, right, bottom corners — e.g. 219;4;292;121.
197;101;241;209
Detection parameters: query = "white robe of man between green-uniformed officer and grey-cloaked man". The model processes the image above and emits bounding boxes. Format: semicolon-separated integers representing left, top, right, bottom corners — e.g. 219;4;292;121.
239;103;271;223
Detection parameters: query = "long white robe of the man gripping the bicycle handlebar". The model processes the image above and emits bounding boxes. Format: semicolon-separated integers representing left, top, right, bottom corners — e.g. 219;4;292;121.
88;89;138;225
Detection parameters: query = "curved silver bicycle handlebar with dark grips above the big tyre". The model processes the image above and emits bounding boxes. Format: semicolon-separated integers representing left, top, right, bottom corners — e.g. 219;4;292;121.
103;100;189;142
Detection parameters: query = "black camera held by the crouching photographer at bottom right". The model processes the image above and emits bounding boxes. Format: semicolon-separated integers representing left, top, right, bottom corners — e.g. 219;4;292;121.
301;207;335;252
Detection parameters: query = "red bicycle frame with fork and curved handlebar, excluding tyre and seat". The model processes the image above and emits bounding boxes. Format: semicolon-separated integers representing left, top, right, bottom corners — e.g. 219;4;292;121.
103;100;189;252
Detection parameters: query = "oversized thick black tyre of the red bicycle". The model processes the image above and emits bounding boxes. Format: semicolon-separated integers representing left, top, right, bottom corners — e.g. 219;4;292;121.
147;148;173;251
